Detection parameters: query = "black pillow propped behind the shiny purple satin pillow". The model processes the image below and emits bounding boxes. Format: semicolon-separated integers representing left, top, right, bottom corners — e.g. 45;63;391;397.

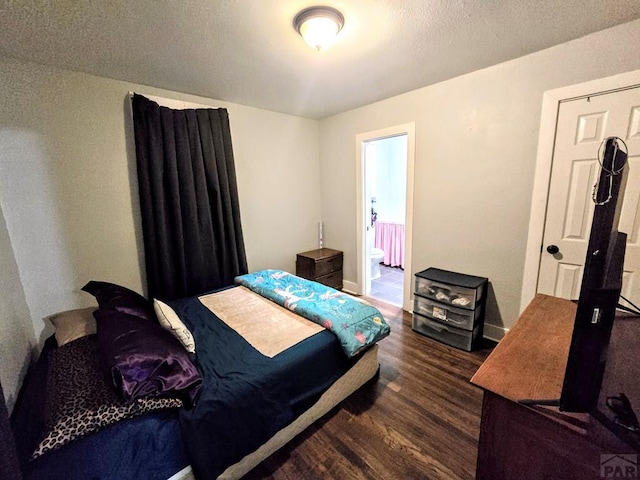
82;280;158;323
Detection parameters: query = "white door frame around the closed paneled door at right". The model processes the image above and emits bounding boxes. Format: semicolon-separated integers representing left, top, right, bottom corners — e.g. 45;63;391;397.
520;70;640;312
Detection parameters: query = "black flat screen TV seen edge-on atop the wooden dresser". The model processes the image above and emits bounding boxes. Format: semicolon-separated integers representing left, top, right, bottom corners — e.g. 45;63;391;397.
559;137;628;413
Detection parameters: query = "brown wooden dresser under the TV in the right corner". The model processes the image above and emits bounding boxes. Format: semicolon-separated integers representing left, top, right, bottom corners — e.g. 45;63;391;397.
471;295;638;480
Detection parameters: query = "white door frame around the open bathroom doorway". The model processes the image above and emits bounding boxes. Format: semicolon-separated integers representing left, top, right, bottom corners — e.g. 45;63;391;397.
356;122;416;311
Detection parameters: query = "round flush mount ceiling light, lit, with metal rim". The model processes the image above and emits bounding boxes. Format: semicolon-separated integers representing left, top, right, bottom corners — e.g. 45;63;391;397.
293;7;344;50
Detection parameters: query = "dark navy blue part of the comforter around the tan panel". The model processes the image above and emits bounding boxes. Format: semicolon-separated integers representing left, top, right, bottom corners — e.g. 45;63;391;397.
168;288;357;480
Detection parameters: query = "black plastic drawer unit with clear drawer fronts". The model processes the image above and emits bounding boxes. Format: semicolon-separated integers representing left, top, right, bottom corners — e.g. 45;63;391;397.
412;268;488;351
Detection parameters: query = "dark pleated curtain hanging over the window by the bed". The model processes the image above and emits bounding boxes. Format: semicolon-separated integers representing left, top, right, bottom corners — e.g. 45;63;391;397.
132;94;247;300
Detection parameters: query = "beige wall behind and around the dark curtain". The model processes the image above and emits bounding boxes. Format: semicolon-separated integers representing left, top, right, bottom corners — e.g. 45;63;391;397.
0;59;321;348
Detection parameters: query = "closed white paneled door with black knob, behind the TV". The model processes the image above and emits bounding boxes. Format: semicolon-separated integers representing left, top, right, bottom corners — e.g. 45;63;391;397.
538;87;640;305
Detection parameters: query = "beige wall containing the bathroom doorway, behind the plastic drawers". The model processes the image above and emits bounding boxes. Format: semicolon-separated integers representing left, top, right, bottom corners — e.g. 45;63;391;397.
320;17;640;336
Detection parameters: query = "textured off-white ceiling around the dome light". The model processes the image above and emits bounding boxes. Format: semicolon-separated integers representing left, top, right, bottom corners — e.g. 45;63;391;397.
0;0;640;118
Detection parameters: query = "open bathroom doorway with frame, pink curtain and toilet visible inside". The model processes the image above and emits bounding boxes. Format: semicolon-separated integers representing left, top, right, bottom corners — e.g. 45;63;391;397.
356;124;414;310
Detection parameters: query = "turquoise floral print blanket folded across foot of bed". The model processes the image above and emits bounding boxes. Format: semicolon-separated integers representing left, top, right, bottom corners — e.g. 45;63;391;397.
235;270;390;358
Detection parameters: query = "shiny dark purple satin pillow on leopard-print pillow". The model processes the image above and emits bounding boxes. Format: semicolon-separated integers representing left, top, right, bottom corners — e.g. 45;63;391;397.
94;309;202;405
